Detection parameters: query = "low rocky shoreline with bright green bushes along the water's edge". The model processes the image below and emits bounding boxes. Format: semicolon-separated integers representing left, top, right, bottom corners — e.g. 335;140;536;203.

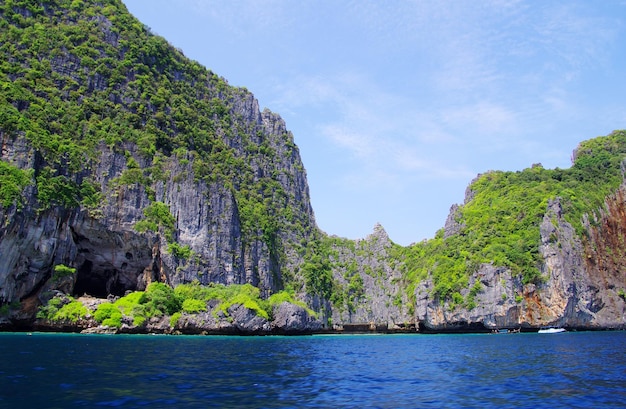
0;291;626;336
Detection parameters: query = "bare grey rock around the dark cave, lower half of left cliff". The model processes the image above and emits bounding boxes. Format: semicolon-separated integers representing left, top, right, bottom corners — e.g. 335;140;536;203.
0;122;314;302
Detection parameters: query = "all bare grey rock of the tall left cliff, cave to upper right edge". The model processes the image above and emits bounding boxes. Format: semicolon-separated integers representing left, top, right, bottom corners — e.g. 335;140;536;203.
0;93;317;310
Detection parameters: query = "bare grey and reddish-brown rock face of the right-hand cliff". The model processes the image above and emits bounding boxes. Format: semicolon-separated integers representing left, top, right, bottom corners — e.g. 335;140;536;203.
414;185;626;332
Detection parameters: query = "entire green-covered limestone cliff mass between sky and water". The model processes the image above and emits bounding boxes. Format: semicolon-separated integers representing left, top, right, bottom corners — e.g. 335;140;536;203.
0;0;626;334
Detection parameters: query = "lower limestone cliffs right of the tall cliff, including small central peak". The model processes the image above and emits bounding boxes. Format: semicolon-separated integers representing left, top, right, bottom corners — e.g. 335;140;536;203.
322;137;626;332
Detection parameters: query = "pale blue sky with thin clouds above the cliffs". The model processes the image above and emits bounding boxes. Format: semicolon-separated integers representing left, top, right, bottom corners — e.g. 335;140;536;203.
123;0;626;245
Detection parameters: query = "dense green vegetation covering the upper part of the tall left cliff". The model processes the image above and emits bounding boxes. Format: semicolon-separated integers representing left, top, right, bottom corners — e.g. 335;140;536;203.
0;0;312;259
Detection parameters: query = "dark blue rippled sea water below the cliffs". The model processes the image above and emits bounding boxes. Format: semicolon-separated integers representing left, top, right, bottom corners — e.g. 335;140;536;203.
0;332;626;409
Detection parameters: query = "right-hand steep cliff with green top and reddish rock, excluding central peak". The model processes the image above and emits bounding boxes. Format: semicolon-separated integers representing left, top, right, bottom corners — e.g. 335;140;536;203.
405;131;626;331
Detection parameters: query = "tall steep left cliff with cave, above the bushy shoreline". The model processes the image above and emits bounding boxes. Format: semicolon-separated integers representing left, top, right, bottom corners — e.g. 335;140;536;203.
0;1;319;328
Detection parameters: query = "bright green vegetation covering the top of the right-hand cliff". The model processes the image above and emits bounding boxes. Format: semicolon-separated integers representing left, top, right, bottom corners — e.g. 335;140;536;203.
398;131;626;301
